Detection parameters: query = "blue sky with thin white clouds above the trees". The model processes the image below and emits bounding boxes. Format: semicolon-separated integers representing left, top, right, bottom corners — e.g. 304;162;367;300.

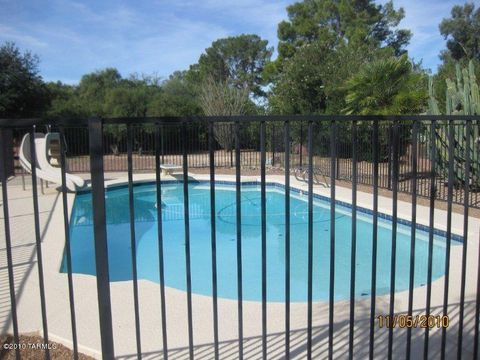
0;0;480;84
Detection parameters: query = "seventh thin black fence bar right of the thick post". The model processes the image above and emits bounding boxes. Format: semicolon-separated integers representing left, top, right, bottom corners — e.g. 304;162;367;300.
284;121;290;360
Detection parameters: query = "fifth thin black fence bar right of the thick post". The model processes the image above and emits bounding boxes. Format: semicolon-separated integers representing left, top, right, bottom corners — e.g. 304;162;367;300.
234;121;243;359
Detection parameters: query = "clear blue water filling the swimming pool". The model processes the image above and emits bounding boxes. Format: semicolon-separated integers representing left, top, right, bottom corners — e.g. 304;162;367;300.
61;182;460;302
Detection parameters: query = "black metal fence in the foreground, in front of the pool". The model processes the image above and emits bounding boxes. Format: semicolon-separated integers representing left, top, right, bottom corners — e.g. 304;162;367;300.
0;116;480;359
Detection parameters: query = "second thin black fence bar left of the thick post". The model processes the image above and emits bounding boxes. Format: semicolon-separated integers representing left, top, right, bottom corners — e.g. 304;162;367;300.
30;126;50;359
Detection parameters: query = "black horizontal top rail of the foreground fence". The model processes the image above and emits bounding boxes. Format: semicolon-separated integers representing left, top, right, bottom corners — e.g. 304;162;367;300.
0;114;480;128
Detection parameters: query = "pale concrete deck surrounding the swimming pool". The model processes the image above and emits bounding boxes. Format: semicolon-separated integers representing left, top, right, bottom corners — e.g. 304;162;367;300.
0;173;480;359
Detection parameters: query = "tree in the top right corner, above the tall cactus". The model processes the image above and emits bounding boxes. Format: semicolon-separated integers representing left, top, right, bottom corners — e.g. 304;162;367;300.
439;3;480;61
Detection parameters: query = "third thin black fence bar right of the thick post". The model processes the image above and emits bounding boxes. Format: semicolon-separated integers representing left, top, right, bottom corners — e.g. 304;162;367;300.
182;121;193;360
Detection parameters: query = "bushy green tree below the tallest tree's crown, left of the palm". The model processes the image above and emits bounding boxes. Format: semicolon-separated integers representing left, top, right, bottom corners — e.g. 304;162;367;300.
269;42;393;114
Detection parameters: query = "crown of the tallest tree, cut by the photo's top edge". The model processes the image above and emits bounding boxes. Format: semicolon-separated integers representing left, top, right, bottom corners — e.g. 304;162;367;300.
278;0;411;61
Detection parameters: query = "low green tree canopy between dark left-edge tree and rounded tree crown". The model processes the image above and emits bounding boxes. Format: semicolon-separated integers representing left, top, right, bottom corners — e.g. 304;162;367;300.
48;68;200;117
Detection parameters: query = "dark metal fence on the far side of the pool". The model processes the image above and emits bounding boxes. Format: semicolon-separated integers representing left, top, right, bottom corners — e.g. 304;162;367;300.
10;117;480;208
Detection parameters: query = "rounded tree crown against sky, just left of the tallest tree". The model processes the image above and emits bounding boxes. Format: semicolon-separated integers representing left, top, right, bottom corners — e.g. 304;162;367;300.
191;34;273;96
